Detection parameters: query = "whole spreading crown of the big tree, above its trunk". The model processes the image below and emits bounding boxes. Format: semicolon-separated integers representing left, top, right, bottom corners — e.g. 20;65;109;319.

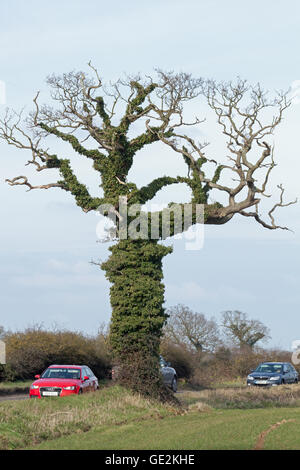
0;67;296;229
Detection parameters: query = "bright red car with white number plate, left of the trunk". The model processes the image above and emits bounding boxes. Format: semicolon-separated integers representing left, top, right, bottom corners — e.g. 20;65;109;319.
29;365;99;398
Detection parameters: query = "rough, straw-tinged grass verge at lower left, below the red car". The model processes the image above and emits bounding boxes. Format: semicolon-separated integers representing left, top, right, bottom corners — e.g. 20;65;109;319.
0;386;178;449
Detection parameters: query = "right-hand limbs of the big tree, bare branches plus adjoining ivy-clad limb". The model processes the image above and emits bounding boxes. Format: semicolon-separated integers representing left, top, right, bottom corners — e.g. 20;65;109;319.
154;79;297;229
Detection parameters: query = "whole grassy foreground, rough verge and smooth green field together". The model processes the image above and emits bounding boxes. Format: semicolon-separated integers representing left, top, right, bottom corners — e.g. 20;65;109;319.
0;386;300;450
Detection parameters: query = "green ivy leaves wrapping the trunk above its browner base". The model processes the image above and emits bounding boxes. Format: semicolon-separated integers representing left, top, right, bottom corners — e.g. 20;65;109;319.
101;240;172;357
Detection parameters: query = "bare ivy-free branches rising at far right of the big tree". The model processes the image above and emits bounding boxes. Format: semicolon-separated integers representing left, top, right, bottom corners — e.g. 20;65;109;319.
203;79;296;229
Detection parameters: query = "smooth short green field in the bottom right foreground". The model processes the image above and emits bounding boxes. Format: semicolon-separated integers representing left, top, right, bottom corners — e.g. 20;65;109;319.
32;408;300;450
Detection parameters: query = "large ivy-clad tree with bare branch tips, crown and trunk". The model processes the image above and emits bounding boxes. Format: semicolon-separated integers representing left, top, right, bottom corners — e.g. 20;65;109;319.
0;64;296;396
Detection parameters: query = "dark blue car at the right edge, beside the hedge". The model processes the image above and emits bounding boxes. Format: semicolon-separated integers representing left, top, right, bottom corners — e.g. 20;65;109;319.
247;362;298;386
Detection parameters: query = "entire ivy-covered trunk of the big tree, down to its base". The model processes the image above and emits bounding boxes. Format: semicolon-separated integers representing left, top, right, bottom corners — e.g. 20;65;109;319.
101;240;172;397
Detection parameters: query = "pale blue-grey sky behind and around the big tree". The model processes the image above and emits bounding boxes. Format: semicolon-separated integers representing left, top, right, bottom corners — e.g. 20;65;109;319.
0;0;300;349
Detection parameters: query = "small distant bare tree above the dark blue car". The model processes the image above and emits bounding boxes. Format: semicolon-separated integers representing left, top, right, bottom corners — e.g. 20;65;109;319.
222;310;270;349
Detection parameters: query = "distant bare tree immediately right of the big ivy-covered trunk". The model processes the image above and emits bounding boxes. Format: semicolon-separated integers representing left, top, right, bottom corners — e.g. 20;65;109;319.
164;304;220;352
